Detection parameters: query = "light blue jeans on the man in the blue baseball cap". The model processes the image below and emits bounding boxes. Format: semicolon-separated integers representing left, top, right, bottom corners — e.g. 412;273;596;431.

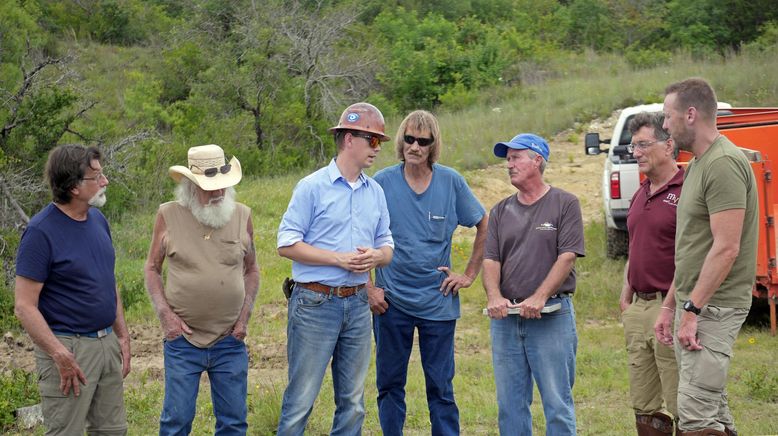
491;297;578;436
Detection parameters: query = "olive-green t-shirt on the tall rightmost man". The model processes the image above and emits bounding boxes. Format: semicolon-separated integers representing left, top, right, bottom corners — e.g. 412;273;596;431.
675;136;759;308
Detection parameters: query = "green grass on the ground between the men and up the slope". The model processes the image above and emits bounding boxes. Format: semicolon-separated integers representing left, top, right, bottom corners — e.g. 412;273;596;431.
7;46;778;435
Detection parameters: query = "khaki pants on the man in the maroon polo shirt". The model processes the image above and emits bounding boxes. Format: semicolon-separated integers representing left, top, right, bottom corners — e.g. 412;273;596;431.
621;293;678;417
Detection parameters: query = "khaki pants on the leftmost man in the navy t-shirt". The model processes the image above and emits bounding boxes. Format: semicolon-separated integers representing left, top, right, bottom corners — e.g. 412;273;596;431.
35;333;127;436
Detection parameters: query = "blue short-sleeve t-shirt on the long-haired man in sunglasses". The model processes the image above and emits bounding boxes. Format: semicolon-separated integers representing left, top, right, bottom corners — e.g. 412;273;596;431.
374;164;486;321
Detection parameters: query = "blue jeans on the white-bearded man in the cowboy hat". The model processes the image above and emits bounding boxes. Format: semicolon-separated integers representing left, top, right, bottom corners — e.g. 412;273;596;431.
159;335;244;435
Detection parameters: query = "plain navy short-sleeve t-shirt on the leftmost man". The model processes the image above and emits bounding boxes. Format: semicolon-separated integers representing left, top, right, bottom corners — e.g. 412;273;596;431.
16;204;116;333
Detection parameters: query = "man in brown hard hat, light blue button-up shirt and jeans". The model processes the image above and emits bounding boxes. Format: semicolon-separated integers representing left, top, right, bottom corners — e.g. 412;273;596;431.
277;103;394;436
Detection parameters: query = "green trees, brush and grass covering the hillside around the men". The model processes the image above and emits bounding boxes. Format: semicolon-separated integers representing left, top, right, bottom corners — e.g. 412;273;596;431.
0;0;778;435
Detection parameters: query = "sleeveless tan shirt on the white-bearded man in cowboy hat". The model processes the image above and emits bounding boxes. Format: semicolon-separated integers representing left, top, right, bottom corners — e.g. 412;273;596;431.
159;202;251;348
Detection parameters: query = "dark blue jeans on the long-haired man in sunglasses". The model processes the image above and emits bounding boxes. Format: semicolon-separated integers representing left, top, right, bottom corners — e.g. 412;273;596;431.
373;303;459;436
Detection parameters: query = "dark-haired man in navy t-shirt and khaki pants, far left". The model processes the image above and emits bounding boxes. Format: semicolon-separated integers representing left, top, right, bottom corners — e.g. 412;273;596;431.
15;145;130;435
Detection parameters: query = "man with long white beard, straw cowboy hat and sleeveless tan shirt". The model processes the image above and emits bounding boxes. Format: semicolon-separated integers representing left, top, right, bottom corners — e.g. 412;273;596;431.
145;145;259;435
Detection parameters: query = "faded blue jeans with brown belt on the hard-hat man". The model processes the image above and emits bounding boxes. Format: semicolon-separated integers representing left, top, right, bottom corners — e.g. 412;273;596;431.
278;285;371;436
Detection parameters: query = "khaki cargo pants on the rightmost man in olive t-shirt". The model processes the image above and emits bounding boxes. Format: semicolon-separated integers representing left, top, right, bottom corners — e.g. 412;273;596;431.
675;305;748;431
